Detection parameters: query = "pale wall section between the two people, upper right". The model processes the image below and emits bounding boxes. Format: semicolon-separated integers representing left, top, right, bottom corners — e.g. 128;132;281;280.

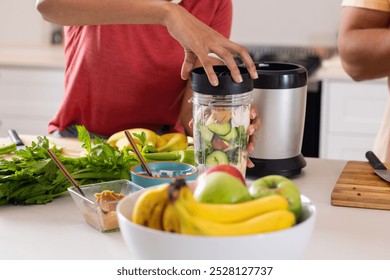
231;0;342;47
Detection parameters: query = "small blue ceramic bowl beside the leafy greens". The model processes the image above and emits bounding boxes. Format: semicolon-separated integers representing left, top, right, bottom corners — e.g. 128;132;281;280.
130;161;198;188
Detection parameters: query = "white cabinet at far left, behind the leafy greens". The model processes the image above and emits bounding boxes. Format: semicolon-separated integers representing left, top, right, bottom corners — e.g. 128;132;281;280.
0;65;64;136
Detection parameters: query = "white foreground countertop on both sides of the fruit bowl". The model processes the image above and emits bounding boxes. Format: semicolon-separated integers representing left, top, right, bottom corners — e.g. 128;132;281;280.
0;158;390;260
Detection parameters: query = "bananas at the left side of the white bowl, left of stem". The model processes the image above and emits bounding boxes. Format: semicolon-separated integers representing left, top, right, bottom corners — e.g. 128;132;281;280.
131;183;180;233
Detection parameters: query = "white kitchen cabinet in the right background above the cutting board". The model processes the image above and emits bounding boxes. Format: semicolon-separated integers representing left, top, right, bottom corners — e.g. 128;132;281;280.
320;76;388;160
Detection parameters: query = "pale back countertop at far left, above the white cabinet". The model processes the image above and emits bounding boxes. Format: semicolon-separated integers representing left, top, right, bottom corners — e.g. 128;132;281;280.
0;45;65;68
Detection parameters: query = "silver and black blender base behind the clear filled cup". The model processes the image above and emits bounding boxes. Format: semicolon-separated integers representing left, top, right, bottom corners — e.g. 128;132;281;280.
247;62;308;178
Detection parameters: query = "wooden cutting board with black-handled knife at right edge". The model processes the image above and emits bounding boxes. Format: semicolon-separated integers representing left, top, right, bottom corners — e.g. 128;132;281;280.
331;161;390;210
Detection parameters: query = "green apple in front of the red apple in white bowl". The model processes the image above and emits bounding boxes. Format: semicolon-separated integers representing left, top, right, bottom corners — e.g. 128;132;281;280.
194;171;251;204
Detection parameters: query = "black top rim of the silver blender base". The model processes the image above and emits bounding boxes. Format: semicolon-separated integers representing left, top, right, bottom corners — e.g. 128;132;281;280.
253;62;308;89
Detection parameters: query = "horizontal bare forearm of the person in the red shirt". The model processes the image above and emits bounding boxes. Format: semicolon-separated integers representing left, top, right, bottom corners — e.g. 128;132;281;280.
36;0;175;26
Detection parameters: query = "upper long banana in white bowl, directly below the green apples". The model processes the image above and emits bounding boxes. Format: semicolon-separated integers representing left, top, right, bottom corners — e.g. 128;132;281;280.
175;187;288;223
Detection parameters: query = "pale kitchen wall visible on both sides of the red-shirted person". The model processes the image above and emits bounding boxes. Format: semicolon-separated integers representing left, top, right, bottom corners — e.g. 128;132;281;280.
0;0;341;46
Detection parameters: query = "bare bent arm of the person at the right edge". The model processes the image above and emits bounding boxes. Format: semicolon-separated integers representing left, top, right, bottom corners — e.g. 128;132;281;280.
338;29;390;80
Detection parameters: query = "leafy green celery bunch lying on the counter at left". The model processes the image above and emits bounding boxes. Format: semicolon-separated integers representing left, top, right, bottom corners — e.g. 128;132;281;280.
0;126;138;205
